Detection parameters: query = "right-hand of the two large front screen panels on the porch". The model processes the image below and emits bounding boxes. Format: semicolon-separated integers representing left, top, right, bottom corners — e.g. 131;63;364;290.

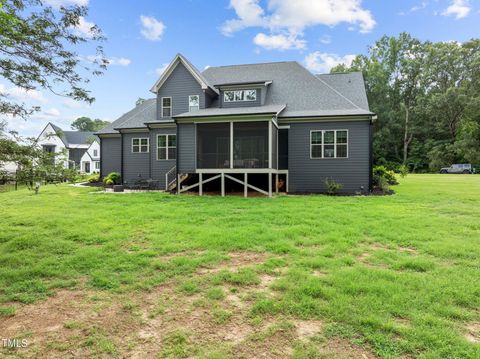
233;121;268;168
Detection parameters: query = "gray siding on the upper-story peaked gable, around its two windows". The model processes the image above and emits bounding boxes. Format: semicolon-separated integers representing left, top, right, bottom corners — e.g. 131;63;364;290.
157;63;205;119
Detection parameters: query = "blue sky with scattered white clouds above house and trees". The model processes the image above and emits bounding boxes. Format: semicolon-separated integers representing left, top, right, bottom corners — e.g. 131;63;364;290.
4;0;480;136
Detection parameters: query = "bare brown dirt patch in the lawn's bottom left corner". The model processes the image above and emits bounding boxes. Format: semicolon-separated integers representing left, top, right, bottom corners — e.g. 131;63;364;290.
0;289;138;358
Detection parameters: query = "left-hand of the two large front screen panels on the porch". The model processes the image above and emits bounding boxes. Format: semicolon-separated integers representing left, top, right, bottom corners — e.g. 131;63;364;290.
197;123;230;168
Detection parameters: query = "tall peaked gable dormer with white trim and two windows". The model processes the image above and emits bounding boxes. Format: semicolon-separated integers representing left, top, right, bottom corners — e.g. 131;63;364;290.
150;54;219;121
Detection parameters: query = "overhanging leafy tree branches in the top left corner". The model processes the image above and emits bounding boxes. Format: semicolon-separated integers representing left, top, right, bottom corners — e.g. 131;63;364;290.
0;0;108;118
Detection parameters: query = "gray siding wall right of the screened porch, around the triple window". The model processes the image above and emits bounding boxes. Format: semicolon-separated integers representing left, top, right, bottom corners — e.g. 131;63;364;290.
288;121;370;192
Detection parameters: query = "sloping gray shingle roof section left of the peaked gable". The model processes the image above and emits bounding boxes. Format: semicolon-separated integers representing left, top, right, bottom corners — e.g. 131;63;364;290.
96;98;157;135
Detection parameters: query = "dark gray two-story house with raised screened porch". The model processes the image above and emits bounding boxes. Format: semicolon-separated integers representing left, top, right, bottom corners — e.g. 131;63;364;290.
97;54;375;195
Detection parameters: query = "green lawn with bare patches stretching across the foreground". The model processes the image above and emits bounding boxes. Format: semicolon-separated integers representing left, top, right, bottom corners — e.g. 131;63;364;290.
0;175;480;358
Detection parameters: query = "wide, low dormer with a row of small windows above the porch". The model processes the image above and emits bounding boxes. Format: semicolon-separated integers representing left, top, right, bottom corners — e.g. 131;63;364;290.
215;81;272;108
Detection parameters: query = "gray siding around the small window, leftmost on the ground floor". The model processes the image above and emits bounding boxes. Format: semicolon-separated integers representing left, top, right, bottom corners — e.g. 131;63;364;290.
122;132;150;183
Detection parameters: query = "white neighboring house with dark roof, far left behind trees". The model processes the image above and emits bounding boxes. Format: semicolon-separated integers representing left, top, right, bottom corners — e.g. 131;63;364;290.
37;122;100;173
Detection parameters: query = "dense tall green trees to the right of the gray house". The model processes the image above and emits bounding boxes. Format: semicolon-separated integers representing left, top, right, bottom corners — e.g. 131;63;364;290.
331;33;480;171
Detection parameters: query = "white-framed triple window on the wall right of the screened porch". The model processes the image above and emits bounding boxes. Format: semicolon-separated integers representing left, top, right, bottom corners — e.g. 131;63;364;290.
310;130;348;158
